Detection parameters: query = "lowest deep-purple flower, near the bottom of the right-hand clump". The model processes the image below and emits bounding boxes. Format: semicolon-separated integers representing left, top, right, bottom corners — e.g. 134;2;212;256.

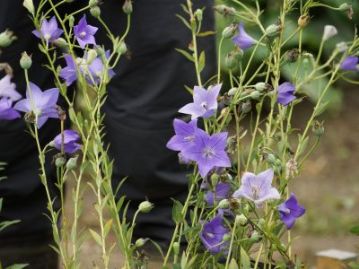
199;215;229;254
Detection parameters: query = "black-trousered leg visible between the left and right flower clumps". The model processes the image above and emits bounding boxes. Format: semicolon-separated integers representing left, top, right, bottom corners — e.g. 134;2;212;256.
97;0;215;247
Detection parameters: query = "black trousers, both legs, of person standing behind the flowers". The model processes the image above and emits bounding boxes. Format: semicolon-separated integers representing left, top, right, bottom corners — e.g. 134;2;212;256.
0;0;215;268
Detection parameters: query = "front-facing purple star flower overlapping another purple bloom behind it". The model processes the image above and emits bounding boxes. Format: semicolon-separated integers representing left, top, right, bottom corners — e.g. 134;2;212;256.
182;129;231;178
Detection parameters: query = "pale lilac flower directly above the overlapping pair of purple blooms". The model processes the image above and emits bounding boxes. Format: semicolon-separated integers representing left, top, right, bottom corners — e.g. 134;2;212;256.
179;84;222;120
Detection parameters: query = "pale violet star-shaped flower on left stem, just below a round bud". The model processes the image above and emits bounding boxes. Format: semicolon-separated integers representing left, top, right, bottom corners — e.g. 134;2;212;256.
14;82;59;129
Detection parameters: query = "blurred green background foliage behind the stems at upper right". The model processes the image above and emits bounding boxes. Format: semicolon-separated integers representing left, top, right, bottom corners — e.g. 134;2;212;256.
216;0;359;111
